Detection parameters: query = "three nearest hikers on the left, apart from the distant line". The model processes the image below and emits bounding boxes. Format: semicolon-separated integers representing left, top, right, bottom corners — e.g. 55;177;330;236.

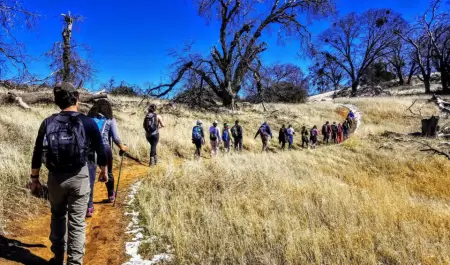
30;83;164;265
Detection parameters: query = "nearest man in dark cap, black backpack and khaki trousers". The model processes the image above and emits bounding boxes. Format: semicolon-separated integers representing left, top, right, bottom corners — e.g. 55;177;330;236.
30;82;108;265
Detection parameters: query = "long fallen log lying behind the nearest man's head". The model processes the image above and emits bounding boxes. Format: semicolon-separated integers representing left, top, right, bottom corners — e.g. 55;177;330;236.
0;89;108;109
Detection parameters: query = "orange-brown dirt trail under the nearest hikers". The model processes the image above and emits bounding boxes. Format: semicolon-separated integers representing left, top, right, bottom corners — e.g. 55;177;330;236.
0;162;150;265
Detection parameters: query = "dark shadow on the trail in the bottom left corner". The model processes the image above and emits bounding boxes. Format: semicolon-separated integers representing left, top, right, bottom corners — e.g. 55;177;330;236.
0;235;48;265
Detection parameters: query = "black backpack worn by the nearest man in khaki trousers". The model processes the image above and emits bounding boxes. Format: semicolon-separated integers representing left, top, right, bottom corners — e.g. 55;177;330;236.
44;113;88;172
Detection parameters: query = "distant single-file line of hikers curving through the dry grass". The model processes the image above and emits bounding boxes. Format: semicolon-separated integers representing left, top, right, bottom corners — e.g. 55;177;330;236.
192;111;355;158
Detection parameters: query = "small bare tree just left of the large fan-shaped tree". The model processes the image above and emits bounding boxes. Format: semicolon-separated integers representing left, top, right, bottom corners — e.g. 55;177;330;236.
309;52;344;93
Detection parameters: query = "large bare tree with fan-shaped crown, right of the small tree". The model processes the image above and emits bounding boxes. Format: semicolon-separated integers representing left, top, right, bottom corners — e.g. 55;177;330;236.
319;9;405;95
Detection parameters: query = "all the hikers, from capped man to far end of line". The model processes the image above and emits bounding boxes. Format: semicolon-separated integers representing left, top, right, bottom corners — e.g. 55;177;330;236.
30;83;354;265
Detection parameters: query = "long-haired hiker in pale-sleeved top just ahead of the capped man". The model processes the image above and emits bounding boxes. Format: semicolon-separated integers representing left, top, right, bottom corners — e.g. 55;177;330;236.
86;99;128;217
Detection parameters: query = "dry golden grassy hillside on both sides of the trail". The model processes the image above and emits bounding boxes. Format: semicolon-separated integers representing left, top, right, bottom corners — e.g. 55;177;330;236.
0;94;450;264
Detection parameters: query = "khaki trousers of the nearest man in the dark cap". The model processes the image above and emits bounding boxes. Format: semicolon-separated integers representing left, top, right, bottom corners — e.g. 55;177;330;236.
48;166;91;265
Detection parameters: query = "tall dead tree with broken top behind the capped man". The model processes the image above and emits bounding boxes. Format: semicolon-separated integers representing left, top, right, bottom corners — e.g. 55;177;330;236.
46;11;95;87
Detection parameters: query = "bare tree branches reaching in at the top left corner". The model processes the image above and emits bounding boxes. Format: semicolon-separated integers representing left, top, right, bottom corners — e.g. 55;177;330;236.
0;0;38;75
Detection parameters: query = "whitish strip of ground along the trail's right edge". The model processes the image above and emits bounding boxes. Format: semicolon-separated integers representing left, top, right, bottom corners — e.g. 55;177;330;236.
122;181;173;265
